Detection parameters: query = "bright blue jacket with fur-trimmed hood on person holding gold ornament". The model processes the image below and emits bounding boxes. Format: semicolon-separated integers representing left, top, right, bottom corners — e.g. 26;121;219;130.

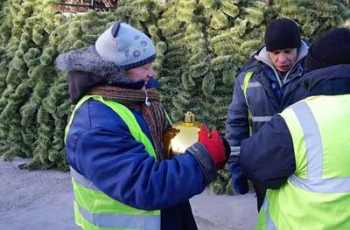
56;47;216;230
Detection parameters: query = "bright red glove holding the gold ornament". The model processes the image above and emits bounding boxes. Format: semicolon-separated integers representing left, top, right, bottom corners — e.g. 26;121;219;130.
198;125;226;169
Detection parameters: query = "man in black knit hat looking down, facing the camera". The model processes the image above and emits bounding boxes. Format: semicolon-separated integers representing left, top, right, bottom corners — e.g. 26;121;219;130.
226;18;308;209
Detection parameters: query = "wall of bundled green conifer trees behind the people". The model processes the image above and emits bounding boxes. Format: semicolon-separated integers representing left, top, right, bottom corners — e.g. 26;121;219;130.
0;0;350;194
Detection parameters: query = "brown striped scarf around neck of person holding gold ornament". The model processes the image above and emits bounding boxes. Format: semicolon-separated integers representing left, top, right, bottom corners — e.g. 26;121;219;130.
89;85;168;160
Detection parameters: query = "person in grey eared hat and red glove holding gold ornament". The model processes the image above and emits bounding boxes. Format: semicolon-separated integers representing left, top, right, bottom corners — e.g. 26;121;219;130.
56;21;229;230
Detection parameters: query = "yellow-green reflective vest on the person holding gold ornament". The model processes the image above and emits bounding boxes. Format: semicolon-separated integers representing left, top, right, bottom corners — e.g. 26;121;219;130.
65;95;160;230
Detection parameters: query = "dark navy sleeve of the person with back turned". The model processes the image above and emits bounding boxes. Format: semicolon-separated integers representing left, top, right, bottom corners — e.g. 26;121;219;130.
239;115;295;189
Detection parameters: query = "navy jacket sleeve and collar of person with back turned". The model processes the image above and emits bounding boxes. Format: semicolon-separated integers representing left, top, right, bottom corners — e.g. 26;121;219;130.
239;65;350;189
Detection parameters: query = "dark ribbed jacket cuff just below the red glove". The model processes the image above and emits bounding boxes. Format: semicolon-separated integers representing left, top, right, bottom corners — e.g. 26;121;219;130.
187;142;217;184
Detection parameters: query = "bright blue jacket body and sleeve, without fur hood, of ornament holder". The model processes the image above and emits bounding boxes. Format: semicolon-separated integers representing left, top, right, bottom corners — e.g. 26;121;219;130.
66;100;213;230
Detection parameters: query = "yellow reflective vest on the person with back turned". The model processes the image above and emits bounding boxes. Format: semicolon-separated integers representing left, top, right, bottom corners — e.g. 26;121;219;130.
257;95;350;229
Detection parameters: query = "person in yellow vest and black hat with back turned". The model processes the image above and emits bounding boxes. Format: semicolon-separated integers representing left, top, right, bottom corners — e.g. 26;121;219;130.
239;28;350;230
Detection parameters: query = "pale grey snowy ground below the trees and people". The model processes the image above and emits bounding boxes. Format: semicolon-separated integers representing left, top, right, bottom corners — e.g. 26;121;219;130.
0;158;257;230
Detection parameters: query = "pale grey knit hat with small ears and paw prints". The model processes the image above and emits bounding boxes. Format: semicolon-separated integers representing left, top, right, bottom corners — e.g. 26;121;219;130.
95;21;156;70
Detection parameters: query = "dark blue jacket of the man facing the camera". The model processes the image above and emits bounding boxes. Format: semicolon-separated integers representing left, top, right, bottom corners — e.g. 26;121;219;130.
226;42;308;151
